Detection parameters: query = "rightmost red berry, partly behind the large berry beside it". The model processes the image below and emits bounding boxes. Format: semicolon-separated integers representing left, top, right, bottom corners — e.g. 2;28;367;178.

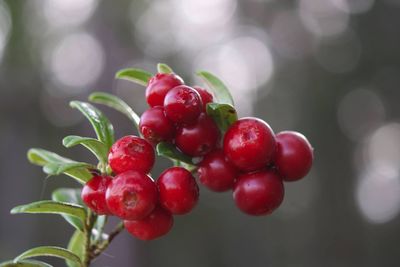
274;131;313;181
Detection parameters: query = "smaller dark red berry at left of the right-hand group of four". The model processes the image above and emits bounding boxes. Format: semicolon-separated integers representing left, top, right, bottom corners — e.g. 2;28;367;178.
197;150;238;192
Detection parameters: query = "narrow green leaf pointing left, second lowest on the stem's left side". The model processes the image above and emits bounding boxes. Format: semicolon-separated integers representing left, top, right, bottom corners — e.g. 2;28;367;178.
11;200;86;231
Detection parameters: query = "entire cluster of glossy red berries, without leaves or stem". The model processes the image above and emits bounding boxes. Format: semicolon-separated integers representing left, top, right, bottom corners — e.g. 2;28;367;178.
82;70;313;240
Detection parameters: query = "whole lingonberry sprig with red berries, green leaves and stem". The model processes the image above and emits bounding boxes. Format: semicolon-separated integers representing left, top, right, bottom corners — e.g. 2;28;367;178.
0;63;313;267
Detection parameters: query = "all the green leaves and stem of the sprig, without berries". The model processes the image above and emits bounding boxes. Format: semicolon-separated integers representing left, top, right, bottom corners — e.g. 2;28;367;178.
0;63;237;267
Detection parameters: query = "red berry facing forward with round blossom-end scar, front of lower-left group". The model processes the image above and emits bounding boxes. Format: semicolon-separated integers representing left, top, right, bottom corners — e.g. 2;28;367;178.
106;171;158;220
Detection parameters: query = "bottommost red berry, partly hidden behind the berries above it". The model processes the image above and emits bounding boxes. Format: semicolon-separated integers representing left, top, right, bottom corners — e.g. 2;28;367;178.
124;207;174;240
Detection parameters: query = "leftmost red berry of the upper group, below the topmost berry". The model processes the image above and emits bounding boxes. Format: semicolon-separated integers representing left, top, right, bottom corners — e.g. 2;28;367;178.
139;107;175;144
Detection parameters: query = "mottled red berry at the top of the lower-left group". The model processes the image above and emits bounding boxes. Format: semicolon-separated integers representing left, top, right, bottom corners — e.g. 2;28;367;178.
108;135;155;174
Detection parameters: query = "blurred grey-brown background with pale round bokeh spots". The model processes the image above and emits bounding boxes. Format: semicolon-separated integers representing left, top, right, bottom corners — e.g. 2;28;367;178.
0;0;400;267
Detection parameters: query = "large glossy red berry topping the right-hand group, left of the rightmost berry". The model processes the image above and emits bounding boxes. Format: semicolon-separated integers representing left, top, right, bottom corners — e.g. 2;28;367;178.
224;117;275;171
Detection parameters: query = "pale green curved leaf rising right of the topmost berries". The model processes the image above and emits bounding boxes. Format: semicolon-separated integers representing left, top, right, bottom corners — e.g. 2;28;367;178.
197;71;234;106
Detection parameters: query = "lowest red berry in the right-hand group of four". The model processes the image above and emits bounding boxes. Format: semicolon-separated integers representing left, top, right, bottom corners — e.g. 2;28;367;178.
233;171;285;216
